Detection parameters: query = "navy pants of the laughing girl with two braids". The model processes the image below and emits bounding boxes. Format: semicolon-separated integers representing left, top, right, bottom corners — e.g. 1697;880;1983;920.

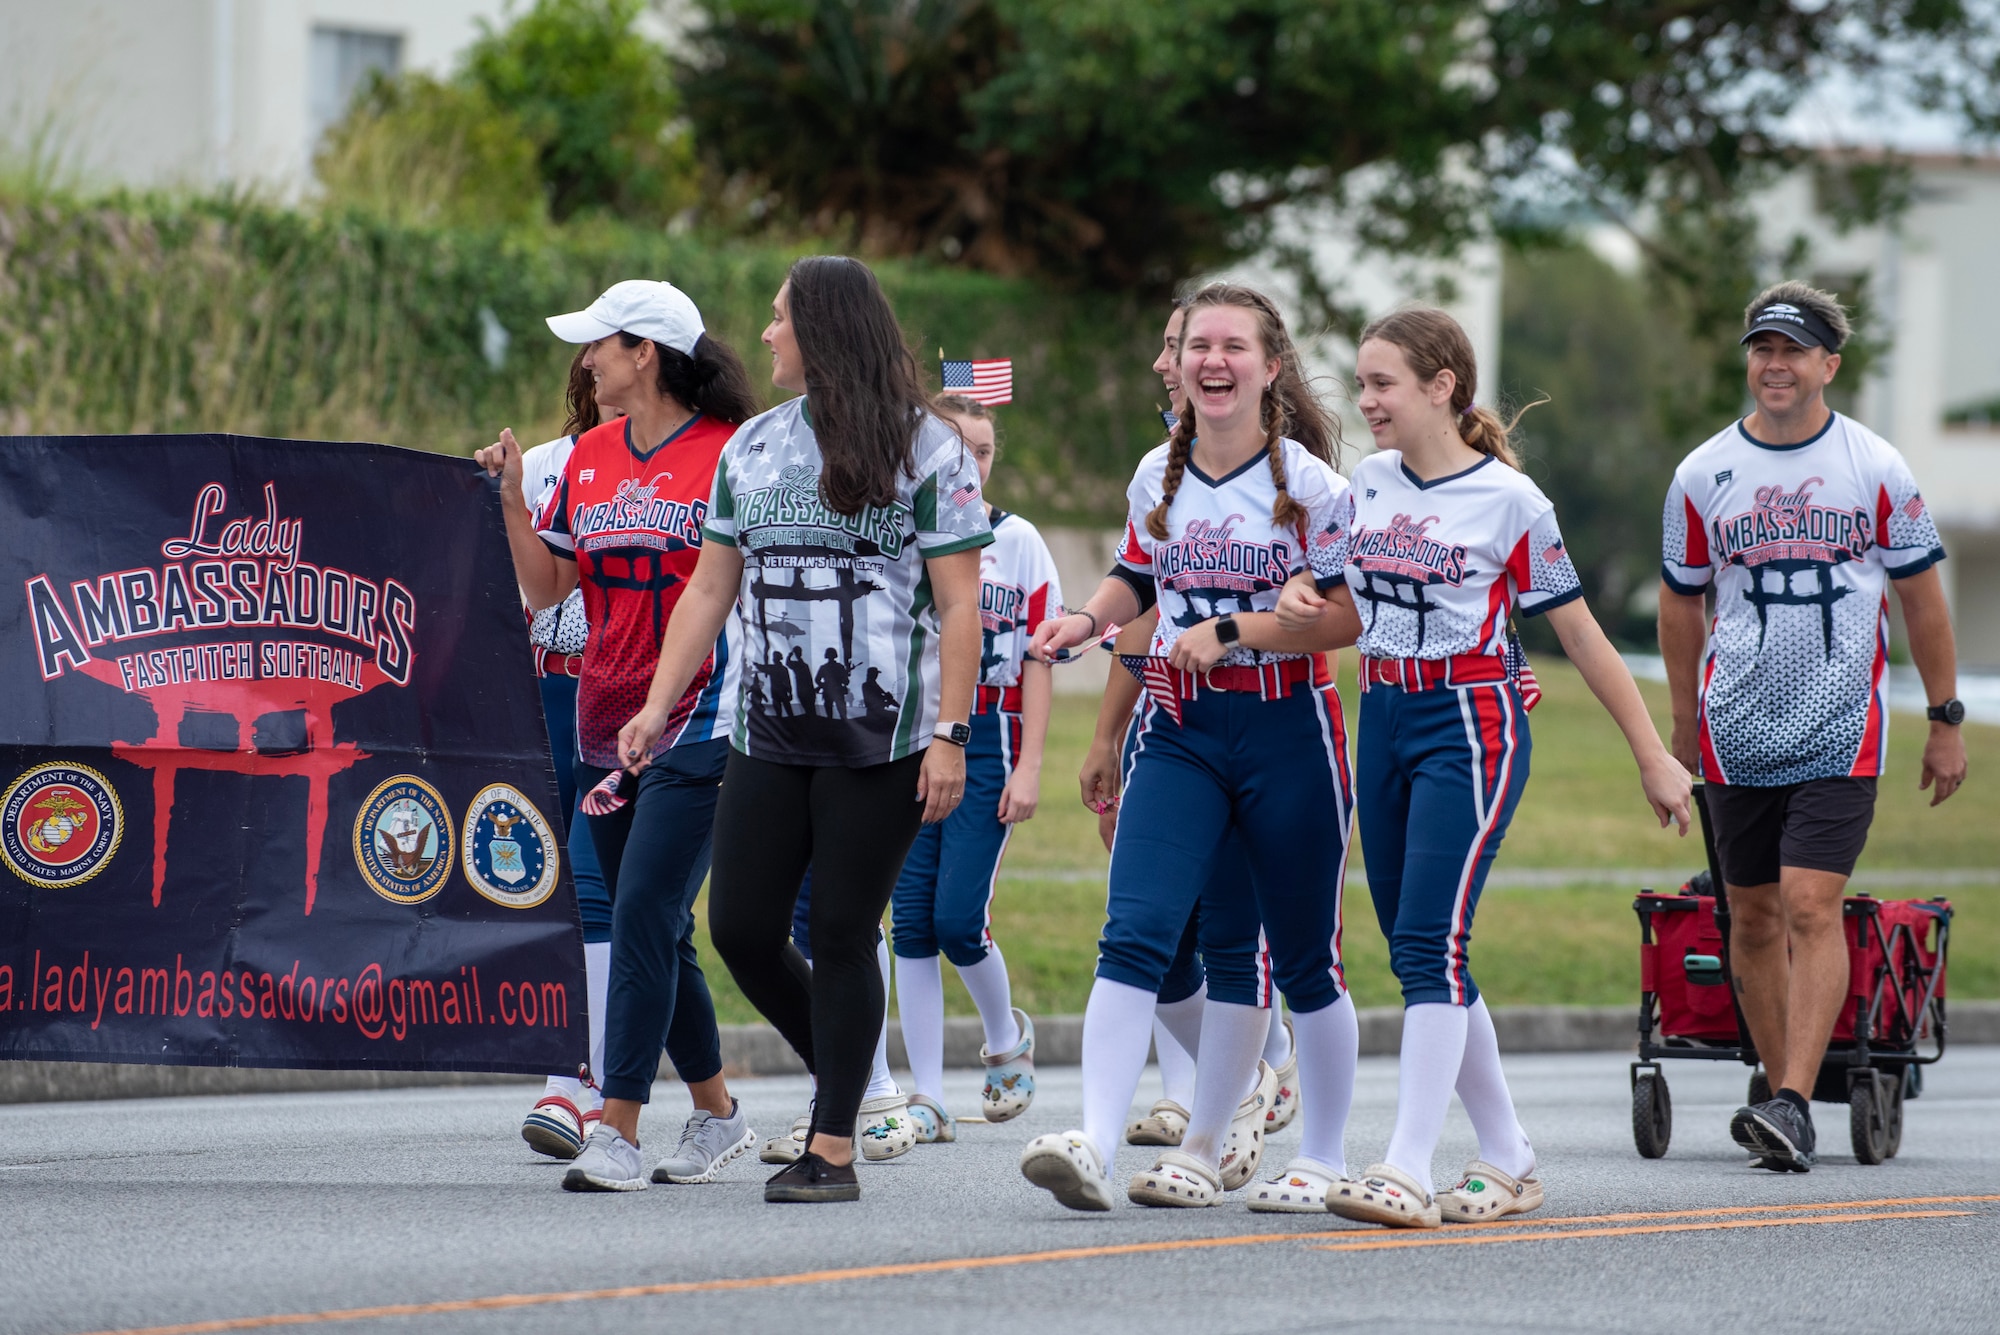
1098;681;1354;1011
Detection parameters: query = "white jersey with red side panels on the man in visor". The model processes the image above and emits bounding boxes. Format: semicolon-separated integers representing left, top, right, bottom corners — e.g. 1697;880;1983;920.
1660;414;1944;787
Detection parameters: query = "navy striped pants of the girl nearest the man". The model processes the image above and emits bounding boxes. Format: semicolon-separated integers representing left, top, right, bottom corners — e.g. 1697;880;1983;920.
1356;681;1532;1005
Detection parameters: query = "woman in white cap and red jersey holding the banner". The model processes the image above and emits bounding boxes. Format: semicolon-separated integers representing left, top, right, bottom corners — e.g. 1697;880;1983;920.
480;280;756;1191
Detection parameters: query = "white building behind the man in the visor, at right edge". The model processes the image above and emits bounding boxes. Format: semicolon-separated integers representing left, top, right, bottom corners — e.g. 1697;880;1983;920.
1758;154;2000;668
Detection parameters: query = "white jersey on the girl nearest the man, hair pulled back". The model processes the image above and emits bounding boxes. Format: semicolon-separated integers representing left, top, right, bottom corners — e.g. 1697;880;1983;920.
1348;450;1584;658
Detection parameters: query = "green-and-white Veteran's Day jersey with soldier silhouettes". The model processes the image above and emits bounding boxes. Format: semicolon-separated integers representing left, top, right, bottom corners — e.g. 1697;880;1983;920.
702;398;994;767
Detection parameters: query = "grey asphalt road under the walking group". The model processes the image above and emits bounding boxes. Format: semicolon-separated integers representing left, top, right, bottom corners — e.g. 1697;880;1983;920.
0;1047;2000;1335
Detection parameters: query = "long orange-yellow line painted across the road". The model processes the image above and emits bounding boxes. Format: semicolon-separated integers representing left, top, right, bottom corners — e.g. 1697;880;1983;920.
70;1195;2000;1335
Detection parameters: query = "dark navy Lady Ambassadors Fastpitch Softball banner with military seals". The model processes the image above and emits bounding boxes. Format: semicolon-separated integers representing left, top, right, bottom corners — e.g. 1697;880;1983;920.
0;436;588;1073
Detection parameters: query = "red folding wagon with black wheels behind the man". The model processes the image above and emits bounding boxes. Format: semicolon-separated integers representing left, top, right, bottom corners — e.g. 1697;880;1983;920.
1632;787;1952;1163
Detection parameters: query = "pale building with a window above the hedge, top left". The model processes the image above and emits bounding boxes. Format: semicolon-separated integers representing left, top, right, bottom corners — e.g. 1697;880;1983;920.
0;0;506;196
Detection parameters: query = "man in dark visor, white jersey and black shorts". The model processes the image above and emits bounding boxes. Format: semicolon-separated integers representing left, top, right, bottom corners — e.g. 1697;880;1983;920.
1660;282;1966;1173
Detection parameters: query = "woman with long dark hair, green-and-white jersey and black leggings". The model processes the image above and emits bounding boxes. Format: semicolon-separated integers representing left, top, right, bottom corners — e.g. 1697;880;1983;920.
618;256;992;1201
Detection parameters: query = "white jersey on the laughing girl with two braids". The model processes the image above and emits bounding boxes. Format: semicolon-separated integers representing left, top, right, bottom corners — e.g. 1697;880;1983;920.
1118;440;1354;668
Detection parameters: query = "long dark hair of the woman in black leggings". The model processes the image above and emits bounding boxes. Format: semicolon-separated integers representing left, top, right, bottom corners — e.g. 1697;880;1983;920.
786;256;930;514
